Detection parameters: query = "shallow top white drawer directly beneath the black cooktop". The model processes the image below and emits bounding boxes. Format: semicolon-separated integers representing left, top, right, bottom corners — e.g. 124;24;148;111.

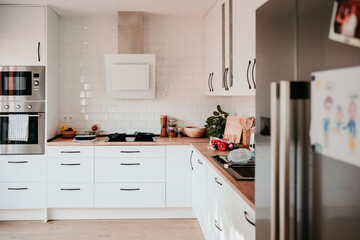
95;146;165;158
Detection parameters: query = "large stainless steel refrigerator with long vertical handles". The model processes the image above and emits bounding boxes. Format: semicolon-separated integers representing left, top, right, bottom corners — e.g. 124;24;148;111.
255;0;360;240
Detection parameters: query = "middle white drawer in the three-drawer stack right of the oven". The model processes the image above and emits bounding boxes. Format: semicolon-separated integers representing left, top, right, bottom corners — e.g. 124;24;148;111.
47;158;94;182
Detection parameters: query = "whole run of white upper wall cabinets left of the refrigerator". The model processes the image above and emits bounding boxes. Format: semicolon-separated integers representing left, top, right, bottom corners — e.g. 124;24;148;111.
204;0;266;96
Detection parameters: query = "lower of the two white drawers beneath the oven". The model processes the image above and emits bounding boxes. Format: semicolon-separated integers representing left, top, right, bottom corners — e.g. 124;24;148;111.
0;183;45;209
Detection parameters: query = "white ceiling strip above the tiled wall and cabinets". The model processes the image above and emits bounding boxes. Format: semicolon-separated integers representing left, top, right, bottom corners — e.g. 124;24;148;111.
0;0;215;16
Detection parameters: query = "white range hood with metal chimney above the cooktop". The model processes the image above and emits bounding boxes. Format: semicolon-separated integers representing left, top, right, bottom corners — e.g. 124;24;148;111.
105;12;156;99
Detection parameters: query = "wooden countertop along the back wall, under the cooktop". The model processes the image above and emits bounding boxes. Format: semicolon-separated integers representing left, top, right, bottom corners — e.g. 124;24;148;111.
47;137;209;146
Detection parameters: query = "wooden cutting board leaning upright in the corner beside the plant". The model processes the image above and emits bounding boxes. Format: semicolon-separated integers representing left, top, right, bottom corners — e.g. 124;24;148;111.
224;116;248;143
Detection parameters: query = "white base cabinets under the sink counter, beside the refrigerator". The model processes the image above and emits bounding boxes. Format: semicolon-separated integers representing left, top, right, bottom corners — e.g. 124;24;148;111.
192;149;255;240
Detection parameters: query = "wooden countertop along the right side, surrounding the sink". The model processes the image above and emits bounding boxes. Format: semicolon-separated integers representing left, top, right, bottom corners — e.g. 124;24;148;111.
191;143;255;209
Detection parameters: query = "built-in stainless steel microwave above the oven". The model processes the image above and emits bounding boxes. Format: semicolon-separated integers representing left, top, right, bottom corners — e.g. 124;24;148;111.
0;66;45;101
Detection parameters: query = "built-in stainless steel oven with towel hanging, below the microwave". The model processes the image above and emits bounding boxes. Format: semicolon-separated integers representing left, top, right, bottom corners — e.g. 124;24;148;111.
0;101;45;154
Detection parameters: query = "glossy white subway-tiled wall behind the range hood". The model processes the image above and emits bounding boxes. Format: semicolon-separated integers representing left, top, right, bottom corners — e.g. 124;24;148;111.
60;13;255;133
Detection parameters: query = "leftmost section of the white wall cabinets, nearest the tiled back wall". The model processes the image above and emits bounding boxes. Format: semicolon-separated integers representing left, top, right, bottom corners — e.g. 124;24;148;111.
204;1;224;95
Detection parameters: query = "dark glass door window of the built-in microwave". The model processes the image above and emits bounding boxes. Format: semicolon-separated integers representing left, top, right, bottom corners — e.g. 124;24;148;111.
0;71;32;96
